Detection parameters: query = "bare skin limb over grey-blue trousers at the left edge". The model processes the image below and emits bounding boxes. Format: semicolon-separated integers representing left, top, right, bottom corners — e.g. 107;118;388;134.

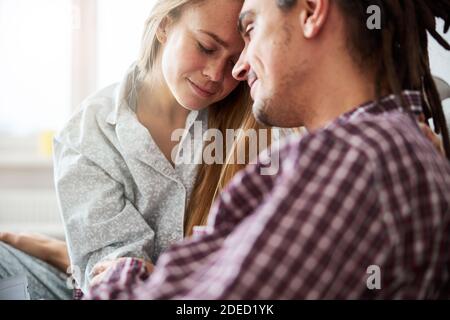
0;232;70;273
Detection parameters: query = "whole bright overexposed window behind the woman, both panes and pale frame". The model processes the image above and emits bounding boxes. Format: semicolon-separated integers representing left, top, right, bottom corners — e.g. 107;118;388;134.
0;0;154;136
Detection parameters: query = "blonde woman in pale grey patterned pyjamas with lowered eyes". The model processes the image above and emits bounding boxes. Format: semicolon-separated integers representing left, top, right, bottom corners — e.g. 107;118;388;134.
0;0;270;299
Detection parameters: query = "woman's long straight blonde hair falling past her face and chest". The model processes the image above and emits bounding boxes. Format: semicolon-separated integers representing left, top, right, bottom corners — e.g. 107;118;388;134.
137;0;271;236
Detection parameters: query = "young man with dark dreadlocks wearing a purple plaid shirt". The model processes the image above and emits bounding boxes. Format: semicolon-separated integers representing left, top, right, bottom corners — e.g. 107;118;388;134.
89;0;450;299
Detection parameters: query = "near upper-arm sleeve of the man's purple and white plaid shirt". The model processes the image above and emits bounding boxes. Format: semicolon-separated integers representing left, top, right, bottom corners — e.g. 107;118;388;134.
211;134;391;299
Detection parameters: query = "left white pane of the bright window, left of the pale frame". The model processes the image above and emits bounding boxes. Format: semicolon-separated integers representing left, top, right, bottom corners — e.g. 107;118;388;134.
0;0;71;134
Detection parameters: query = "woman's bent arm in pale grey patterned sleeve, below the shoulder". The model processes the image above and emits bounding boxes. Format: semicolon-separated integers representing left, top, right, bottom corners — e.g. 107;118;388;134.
54;140;154;291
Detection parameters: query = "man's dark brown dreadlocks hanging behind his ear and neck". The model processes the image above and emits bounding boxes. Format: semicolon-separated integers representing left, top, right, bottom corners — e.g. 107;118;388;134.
276;0;450;159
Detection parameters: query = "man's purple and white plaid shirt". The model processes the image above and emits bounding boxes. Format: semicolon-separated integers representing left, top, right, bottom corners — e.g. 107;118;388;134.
87;92;450;299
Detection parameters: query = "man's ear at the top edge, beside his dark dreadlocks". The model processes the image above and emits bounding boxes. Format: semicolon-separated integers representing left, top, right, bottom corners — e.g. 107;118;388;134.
299;0;330;39
